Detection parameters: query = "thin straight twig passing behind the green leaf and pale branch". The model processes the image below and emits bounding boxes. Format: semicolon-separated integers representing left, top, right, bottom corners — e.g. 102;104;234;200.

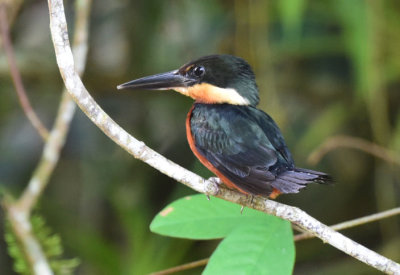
150;207;400;275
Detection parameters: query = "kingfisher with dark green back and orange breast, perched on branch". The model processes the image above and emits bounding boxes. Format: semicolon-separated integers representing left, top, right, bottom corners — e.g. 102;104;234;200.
117;54;331;199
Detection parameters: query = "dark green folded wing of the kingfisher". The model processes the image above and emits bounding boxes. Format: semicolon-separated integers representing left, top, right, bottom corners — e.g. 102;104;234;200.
190;104;293;195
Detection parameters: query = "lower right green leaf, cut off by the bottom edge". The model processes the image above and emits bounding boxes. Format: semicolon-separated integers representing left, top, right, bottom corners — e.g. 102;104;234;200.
203;219;295;275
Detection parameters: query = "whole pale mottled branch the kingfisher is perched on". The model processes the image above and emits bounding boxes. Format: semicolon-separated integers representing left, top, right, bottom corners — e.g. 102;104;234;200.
48;0;400;274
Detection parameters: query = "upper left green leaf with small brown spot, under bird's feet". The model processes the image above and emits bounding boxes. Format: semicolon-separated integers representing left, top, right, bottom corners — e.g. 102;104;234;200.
150;194;279;240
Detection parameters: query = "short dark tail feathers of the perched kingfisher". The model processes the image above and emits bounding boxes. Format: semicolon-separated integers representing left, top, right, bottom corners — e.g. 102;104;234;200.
271;167;333;193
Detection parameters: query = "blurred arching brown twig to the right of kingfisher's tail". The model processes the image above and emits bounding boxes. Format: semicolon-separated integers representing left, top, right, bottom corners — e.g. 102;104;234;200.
308;136;400;166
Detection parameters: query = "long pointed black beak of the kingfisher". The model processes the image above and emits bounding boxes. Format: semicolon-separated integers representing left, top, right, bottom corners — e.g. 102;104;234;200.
117;70;193;90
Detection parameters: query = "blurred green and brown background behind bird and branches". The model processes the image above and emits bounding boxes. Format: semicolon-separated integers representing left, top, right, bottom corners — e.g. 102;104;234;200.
0;0;400;274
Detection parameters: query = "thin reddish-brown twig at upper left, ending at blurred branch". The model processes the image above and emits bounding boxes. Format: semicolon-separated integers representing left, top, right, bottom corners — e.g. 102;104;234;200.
0;3;49;141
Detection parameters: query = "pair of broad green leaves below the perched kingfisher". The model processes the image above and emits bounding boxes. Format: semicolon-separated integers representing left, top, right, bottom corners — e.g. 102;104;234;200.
150;195;295;274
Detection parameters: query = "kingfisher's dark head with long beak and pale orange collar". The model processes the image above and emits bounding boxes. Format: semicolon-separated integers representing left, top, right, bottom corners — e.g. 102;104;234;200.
117;55;259;106
